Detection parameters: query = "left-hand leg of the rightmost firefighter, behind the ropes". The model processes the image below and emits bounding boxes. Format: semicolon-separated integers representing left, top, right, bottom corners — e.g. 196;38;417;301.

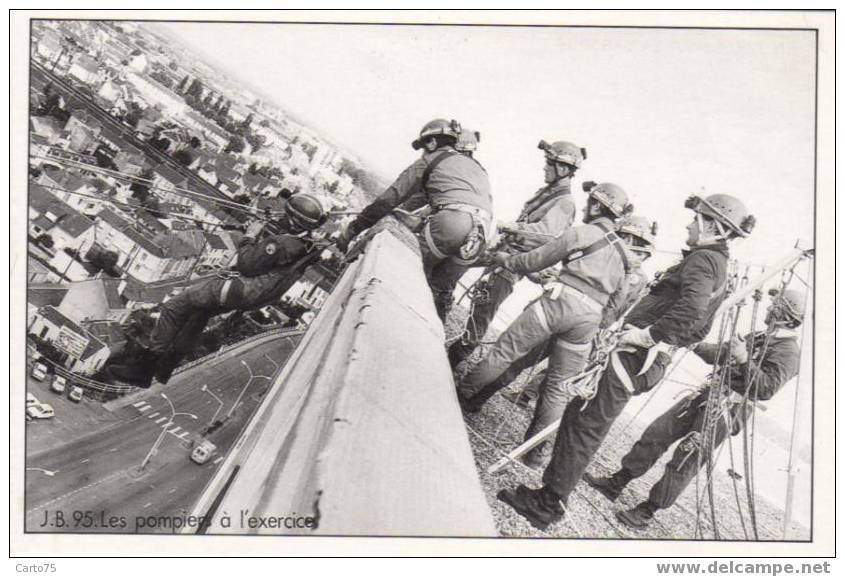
622;398;698;479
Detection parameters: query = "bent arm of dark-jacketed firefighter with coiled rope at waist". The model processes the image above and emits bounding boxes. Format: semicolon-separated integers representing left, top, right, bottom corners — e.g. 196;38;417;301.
650;251;717;345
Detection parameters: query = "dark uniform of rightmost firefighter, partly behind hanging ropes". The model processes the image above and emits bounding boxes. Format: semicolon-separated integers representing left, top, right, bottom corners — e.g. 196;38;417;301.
621;330;800;509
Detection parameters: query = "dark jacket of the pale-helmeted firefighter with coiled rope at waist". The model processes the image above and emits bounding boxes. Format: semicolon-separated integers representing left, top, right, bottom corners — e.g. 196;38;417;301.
627;242;728;347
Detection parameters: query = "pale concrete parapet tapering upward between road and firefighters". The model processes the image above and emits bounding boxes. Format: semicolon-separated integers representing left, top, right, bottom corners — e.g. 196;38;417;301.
192;227;497;537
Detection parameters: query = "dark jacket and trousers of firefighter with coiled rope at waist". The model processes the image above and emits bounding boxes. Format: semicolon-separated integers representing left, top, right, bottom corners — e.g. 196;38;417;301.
543;241;728;504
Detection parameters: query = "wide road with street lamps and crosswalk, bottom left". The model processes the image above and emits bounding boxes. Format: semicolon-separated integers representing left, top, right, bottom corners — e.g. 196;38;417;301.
24;335;301;533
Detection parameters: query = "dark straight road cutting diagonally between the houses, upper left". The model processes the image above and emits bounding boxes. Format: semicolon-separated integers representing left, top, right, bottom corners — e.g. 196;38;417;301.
30;61;245;221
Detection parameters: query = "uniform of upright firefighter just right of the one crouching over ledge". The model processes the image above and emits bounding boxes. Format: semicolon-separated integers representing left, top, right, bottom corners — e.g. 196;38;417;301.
449;179;575;368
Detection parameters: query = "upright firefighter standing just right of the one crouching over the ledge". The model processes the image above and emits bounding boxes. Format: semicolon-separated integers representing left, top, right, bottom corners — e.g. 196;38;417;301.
449;140;587;370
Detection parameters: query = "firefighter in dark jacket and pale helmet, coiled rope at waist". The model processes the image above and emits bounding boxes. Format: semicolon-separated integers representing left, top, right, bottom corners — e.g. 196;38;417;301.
498;194;755;530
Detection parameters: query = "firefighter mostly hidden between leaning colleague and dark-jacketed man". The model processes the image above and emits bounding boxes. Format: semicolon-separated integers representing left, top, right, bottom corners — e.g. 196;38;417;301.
494;215;657;414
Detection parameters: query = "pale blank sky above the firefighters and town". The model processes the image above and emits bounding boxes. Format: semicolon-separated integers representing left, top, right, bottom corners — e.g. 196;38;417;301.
160;23;815;516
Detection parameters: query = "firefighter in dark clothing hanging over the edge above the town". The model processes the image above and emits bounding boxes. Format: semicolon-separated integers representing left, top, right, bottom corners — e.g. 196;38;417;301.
97;193;326;388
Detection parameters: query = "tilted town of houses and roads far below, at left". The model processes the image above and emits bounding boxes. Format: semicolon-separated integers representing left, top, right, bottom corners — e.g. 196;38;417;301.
26;20;380;532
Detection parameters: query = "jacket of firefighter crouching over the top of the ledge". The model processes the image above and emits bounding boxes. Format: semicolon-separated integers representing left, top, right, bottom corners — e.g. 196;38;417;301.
349;148;493;234
